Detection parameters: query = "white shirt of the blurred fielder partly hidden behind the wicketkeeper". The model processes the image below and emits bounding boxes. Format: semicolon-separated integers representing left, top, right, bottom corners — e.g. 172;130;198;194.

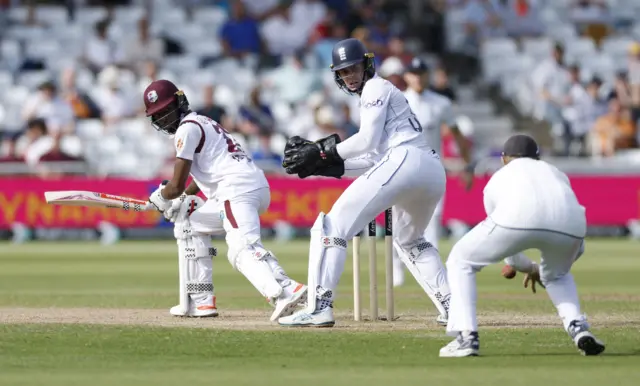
404;89;456;154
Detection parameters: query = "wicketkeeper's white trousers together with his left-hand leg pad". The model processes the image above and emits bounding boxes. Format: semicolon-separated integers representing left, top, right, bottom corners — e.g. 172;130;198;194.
307;146;446;312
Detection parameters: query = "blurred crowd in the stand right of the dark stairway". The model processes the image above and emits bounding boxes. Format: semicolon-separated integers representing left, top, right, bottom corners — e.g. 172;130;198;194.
458;0;640;157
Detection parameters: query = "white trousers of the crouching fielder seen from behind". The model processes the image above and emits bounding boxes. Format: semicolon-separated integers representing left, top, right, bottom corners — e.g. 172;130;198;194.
447;218;584;336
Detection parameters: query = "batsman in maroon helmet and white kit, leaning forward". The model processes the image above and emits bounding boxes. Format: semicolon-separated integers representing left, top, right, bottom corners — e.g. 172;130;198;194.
144;80;307;321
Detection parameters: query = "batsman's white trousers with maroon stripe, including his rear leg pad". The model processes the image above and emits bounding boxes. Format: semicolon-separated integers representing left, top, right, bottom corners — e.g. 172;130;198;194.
190;188;300;304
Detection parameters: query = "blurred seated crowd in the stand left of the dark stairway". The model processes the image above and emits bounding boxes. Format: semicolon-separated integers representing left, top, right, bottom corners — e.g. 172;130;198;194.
0;0;456;177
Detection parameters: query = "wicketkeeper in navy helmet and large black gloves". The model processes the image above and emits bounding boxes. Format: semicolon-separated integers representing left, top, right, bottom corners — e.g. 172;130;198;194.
279;39;449;327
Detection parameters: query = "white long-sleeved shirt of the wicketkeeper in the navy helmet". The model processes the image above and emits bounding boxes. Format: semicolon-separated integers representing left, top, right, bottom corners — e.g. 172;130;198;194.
337;75;428;161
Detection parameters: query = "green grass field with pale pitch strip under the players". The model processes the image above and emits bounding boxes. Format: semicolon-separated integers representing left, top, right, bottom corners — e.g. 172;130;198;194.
0;240;640;386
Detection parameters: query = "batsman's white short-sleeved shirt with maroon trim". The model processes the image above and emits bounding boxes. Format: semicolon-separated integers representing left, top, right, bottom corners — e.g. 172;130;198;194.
174;113;269;201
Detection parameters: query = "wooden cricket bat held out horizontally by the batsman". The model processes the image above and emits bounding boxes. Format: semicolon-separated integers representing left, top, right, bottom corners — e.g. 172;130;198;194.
44;190;149;211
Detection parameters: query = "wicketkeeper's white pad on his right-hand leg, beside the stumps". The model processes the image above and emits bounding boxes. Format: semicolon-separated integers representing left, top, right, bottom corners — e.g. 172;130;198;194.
393;240;451;315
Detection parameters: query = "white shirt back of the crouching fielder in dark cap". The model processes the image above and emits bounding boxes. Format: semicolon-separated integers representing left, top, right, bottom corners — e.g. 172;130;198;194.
484;158;587;238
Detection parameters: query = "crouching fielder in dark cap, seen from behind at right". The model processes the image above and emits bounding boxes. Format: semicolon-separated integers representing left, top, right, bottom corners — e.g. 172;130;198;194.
440;135;605;357
